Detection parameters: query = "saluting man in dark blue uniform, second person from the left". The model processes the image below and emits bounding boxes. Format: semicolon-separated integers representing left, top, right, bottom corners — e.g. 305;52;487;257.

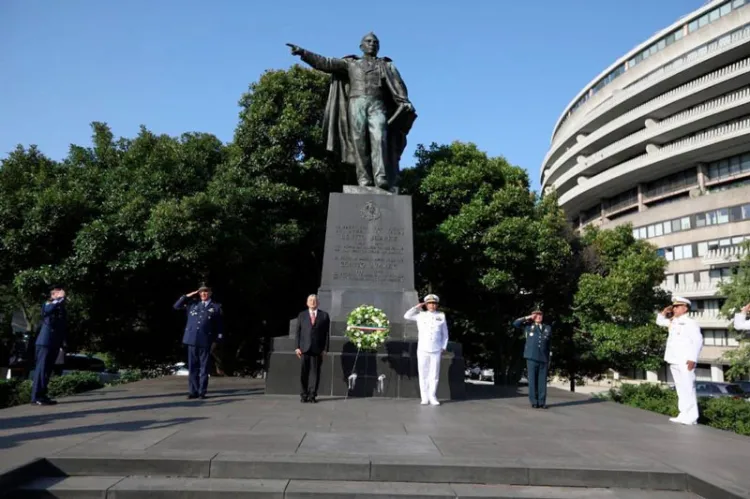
174;284;224;399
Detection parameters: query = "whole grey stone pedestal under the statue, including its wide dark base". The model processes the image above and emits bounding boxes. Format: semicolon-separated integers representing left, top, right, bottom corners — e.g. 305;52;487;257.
266;186;464;399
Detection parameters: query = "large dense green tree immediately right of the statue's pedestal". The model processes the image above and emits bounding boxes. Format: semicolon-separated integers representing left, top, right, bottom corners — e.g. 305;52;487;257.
402;142;572;384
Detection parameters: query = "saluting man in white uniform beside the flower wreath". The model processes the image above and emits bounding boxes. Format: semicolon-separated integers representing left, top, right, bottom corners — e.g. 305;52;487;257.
404;294;448;405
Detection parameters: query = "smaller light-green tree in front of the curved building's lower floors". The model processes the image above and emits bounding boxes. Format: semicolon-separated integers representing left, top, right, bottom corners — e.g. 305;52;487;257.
572;225;668;375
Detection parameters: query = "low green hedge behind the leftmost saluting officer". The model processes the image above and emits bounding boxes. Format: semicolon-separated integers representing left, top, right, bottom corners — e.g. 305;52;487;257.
0;370;151;409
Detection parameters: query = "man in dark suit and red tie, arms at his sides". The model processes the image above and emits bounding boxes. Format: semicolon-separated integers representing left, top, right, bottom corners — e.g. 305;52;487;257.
295;295;331;404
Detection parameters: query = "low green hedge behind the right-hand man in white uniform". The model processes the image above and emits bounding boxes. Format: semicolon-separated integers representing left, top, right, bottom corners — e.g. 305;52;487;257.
606;383;750;436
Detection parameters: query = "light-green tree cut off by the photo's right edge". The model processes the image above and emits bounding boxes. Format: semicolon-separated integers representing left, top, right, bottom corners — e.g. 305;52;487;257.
718;241;750;381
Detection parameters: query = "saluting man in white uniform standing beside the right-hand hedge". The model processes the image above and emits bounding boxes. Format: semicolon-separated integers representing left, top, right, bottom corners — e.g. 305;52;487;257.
656;296;703;425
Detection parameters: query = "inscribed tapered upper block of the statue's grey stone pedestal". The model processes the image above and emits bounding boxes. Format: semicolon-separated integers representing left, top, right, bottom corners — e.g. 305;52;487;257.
318;190;419;339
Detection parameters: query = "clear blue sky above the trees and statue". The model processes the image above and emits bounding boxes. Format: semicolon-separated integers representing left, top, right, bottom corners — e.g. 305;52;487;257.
0;0;704;191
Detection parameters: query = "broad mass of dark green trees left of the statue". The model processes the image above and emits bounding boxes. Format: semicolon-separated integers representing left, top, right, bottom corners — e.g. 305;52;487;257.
0;67;354;368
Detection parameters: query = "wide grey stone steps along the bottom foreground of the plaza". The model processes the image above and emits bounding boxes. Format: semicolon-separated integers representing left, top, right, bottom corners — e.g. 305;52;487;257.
0;456;728;499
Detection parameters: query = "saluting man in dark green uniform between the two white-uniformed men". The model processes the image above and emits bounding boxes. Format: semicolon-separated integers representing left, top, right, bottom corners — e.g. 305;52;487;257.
513;310;552;409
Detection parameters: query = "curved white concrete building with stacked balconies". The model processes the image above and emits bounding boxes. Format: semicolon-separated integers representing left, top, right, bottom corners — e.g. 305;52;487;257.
541;0;750;381
